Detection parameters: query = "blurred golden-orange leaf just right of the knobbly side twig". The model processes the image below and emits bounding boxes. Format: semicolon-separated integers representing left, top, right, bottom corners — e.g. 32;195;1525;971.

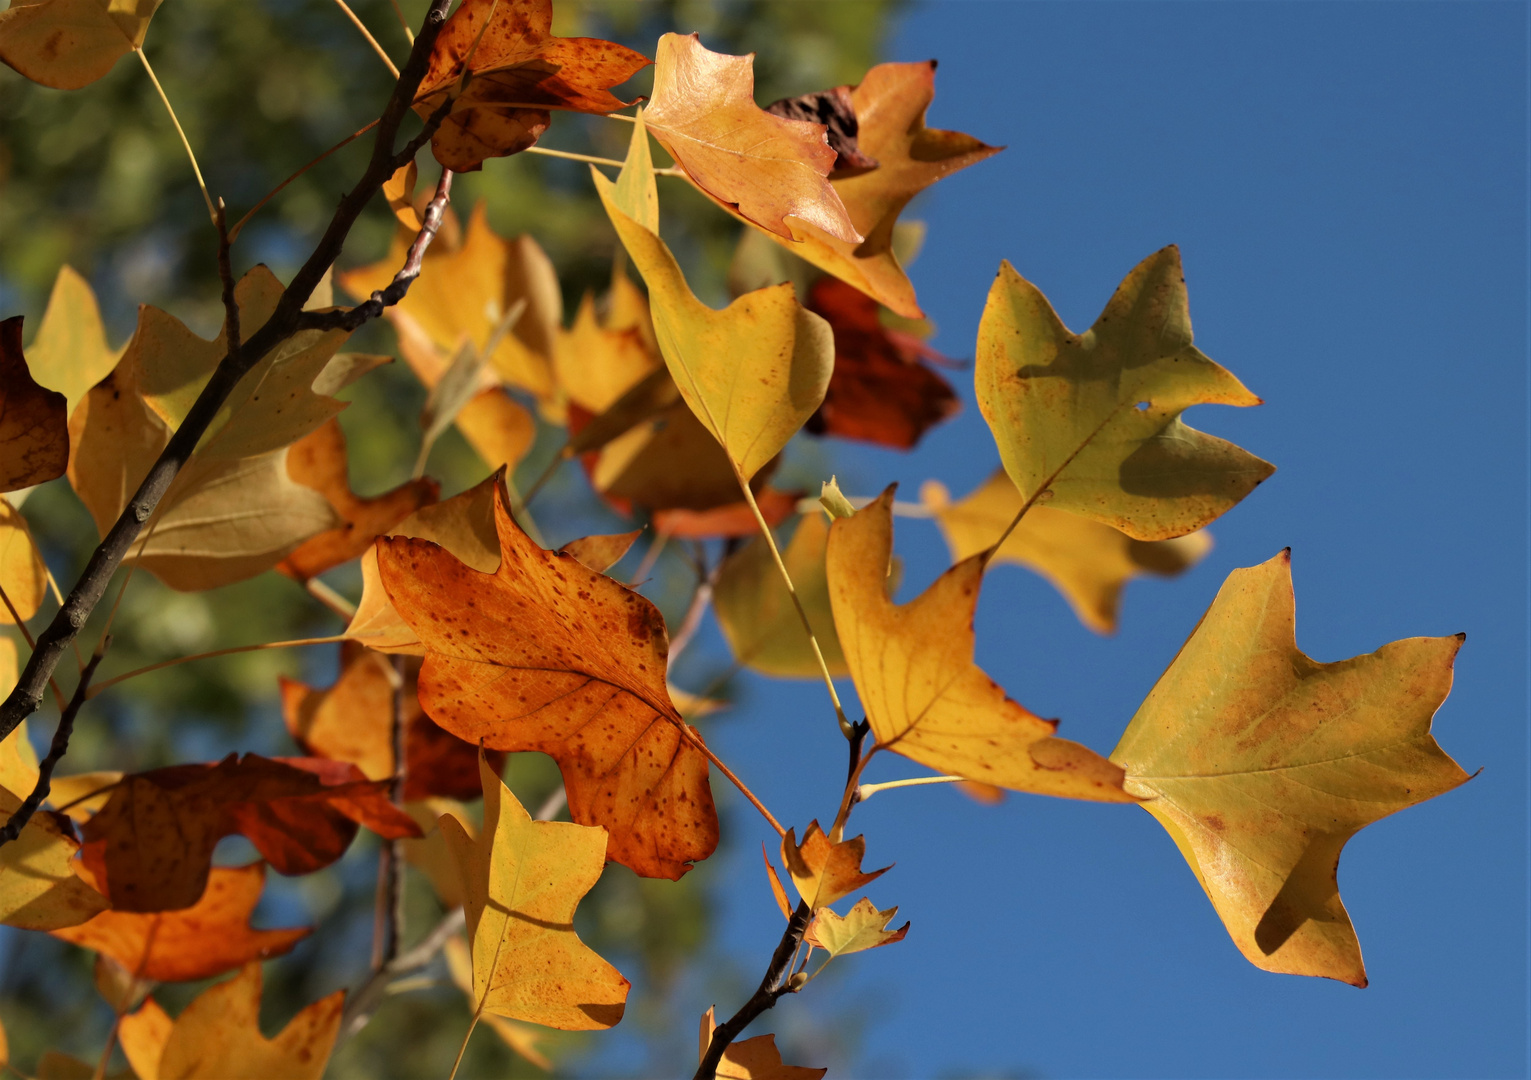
338;203;563;401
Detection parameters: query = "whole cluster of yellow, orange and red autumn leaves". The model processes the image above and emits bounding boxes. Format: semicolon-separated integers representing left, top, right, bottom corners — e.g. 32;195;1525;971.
0;0;1467;1080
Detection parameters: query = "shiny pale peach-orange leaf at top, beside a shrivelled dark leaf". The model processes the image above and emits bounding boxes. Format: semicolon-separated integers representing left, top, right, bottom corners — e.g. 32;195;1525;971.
643;34;862;244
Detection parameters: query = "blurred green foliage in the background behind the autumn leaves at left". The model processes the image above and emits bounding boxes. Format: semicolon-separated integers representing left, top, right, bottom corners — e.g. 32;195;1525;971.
0;0;899;1078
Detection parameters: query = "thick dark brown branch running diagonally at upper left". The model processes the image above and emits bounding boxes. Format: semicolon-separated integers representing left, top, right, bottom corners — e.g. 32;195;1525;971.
0;0;450;790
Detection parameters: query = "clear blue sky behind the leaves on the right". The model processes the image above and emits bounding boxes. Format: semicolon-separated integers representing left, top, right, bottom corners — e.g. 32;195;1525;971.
692;3;1528;1077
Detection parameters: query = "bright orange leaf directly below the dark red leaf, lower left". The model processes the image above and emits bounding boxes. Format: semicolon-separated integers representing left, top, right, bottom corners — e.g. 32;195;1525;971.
54;862;312;982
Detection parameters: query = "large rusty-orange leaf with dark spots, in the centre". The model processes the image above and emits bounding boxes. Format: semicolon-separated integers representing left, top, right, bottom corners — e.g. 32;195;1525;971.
378;489;718;879
